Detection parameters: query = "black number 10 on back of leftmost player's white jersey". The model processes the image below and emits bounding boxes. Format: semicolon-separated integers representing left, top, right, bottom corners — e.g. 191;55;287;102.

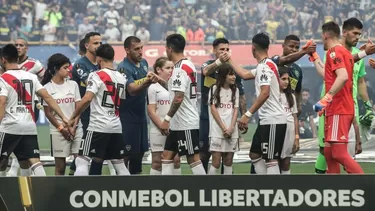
13;79;33;105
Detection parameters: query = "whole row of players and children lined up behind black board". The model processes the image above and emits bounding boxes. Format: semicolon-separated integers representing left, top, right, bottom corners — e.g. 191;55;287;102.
0;19;375;175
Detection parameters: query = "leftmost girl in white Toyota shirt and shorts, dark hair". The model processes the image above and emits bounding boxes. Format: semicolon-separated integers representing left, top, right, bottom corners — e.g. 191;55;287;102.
42;53;83;175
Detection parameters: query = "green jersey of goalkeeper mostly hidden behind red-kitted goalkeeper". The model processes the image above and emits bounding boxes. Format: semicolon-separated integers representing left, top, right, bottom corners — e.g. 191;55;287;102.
319;48;366;141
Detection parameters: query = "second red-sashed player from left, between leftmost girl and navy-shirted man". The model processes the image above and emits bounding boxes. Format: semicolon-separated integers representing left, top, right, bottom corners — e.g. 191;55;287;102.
69;44;129;175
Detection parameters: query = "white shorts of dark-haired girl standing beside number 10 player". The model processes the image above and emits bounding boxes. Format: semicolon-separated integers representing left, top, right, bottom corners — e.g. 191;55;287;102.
51;128;83;158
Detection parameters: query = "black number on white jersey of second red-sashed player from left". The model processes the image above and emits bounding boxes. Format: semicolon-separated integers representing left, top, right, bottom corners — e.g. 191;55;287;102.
102;81;125;109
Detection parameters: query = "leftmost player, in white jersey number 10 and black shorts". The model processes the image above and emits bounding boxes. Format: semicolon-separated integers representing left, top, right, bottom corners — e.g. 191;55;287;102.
0;44;68;176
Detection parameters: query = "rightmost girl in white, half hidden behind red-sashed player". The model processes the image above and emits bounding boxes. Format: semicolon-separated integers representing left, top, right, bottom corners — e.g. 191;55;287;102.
279;67;299;174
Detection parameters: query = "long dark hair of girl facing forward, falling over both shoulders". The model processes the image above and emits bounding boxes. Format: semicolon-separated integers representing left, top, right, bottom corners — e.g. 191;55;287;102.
210;64;237;108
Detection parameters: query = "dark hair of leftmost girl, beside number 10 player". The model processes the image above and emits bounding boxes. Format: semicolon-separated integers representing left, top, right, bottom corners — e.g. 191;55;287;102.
41;53;71;85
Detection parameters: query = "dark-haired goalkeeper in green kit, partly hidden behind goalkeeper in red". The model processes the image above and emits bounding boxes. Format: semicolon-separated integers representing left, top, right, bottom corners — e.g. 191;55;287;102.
315;18;374;174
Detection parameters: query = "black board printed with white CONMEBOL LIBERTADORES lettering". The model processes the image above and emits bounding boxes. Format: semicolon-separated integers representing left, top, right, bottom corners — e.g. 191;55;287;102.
0;175;375;211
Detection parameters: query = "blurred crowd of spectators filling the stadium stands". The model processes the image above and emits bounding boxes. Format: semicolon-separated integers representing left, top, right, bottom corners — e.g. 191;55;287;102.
0;0;375;43
